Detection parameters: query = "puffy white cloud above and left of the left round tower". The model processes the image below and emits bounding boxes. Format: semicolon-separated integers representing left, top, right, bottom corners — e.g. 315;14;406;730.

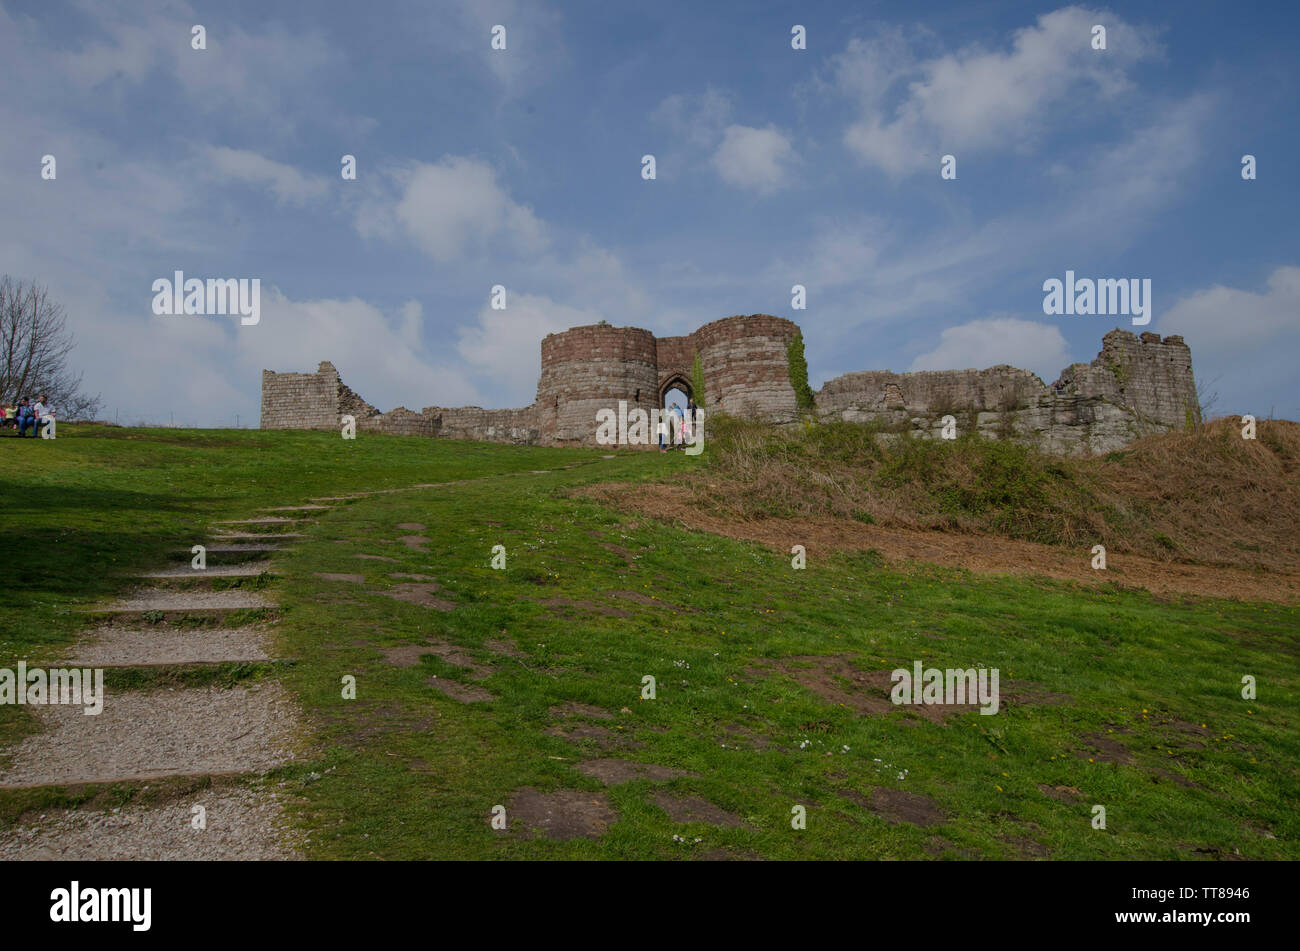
356;156;549;262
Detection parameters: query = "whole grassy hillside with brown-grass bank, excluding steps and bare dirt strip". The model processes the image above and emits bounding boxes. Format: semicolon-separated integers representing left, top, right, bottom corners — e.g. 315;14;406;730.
0;424;1300;859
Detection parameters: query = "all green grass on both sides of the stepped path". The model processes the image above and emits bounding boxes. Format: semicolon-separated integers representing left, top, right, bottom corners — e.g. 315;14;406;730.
0;427;1300;859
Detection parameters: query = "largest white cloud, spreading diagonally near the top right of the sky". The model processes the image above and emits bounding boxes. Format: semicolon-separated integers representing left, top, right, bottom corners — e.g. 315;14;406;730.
832;6;1157;175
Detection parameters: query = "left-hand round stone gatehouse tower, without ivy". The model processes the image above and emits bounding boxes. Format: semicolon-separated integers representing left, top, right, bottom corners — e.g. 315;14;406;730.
536;323;659;446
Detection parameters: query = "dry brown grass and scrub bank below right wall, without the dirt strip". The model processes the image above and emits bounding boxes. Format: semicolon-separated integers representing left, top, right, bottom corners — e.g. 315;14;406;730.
616;417;1300;570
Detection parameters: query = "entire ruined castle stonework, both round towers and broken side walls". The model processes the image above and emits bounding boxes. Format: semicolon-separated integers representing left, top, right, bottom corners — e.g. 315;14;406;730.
261;314;1200;453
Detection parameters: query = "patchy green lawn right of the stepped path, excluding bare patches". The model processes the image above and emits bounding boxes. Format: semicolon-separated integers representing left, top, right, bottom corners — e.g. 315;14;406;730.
266;472;1300;859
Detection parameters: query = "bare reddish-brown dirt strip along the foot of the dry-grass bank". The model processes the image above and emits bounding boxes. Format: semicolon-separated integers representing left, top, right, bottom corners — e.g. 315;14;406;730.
582;482;1300;604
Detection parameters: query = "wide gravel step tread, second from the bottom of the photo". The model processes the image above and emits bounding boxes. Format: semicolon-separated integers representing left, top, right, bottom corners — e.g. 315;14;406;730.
0;682;296;789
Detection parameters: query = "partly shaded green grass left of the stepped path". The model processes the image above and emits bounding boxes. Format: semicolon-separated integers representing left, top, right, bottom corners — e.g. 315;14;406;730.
0;424;599;656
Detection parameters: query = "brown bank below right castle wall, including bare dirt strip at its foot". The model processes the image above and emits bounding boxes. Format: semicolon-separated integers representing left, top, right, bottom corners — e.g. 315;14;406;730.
579;418;1300;600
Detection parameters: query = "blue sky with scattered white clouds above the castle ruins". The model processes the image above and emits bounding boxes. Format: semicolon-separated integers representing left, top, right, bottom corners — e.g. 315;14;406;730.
0;0;1300;426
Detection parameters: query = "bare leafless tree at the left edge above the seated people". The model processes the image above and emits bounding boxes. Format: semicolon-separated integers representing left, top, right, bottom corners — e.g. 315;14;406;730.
0;275;100;420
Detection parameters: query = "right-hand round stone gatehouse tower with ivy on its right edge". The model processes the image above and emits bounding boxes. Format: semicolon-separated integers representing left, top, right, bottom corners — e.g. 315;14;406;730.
692;313;800;422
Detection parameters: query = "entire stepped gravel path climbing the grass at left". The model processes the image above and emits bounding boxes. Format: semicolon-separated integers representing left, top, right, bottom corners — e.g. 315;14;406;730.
0;505;348;860
